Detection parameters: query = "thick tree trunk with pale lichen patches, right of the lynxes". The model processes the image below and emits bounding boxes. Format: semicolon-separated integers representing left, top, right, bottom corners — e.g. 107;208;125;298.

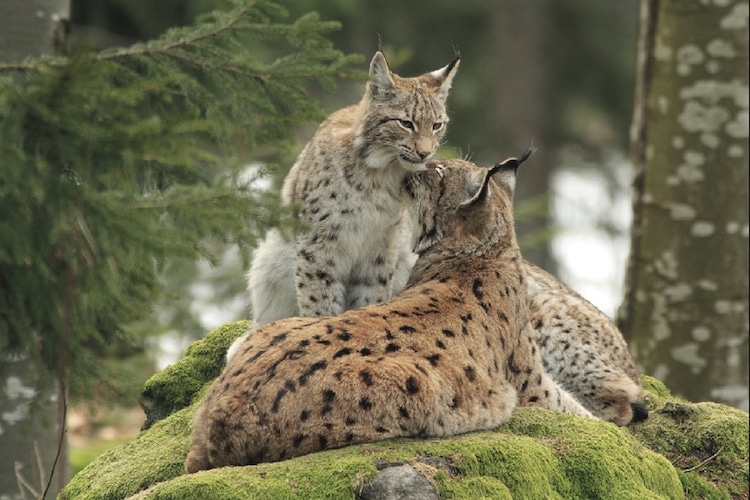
619;0;748;410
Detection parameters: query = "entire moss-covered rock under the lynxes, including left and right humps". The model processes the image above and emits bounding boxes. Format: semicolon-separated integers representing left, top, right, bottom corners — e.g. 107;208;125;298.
60;322;748;500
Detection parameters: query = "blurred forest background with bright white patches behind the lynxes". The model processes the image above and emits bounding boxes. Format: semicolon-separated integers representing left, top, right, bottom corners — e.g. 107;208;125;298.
3;0;747;494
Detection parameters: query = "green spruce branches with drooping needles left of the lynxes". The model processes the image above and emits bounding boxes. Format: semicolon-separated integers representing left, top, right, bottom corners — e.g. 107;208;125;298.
0;0;357;418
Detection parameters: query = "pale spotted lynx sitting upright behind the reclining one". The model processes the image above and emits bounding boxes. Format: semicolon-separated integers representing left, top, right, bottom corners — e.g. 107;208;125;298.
228;52;459;364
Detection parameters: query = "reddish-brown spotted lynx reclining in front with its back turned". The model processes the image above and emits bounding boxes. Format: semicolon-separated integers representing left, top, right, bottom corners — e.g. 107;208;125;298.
186;156;593;472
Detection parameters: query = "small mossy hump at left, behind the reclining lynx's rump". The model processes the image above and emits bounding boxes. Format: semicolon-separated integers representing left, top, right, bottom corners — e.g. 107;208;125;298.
141;321;250;429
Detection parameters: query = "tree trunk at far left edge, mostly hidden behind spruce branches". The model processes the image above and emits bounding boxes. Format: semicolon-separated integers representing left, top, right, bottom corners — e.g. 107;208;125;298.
0;0;70;499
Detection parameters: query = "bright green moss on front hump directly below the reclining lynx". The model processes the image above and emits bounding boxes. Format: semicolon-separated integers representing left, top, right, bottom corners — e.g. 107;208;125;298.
62;408;682;500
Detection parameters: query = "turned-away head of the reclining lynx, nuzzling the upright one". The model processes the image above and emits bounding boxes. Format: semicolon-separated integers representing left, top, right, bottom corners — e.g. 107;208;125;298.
405;149;532;255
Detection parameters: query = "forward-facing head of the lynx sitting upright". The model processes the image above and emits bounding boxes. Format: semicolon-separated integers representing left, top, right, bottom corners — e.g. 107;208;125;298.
356;51;460;171
